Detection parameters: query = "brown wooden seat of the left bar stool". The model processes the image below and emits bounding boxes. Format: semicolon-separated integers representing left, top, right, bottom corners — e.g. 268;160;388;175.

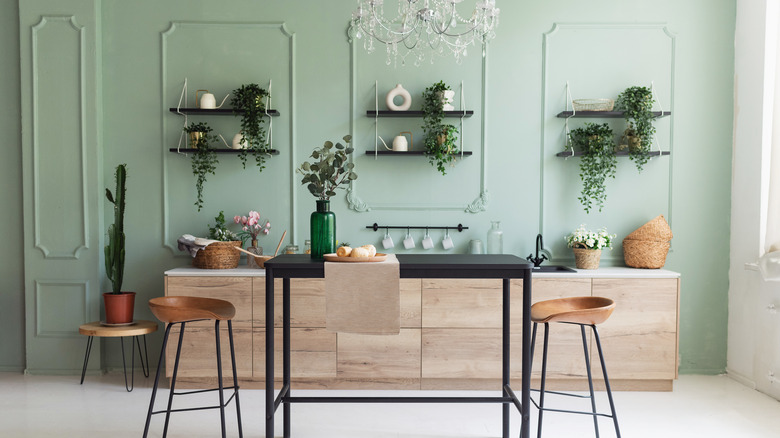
149;297;236;323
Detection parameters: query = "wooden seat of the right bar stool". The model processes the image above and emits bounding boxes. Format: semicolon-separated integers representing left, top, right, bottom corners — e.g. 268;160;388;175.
531;297;615;325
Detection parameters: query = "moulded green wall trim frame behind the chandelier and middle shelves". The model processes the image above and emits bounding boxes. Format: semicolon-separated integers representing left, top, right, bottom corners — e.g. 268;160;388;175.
346;26;490;213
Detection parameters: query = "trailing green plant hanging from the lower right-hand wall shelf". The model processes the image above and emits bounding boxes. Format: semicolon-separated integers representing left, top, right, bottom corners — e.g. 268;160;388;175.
569;123;617;213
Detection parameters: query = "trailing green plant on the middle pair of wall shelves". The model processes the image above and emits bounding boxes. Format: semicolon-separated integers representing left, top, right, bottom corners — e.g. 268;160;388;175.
422;81;460;175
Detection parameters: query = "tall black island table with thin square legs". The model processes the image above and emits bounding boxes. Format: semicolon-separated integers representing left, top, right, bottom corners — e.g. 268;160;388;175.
265;254;533;438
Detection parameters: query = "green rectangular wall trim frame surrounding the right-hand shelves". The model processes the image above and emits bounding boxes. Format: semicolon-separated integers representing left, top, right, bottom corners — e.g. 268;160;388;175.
538;23;677;264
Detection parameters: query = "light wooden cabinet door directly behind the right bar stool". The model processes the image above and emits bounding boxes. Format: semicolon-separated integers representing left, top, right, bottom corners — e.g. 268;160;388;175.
511;278;591;379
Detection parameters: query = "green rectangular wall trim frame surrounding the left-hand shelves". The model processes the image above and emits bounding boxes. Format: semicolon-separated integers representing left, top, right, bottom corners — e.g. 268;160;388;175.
160;21;297;253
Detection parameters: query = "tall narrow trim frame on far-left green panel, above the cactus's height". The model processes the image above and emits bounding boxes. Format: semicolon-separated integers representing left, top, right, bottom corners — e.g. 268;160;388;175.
32;15;89;260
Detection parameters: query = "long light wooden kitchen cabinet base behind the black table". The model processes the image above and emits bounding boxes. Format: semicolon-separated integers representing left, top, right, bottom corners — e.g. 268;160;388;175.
166;268;679;390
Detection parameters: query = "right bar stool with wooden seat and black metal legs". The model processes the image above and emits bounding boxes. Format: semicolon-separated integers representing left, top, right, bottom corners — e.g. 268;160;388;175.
531;297;620;438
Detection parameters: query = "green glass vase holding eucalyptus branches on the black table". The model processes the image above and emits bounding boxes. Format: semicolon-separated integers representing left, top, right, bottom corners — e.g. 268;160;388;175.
296;135;357;259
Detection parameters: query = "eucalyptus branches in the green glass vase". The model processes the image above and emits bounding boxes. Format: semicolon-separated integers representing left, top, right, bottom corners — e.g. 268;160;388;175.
295;135;357;201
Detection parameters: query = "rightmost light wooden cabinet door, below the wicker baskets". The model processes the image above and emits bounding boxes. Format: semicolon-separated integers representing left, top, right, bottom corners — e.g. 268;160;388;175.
591;278;679;380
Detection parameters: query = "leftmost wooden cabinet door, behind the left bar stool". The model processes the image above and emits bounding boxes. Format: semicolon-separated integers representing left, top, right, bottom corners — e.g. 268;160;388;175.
165;277;252;377
